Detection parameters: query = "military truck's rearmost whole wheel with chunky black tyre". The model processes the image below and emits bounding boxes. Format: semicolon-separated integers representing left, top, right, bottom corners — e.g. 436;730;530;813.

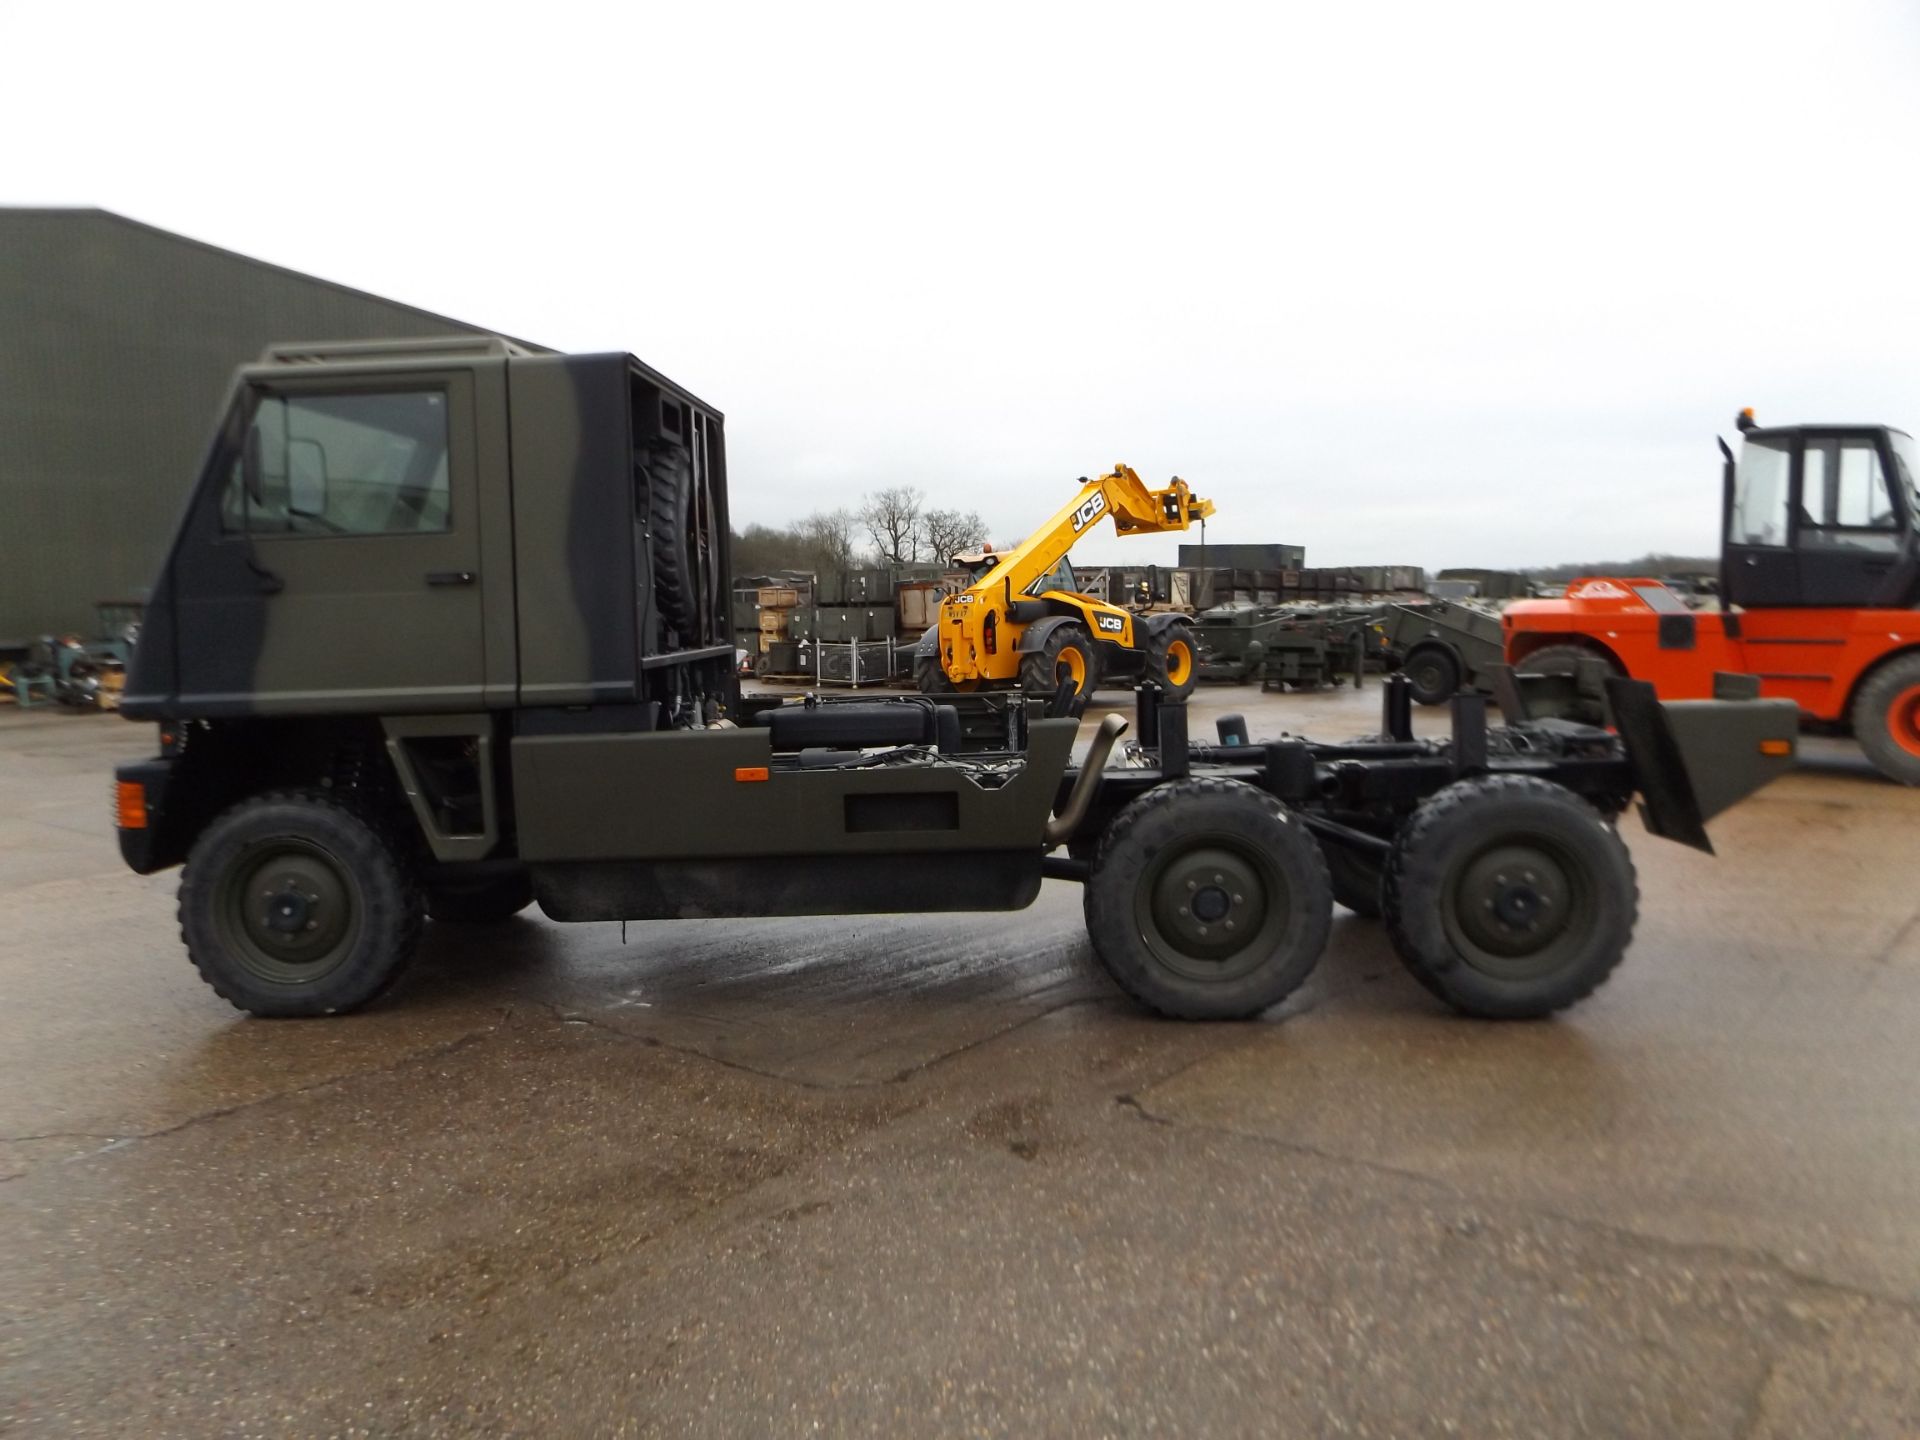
1380;776;1640;1020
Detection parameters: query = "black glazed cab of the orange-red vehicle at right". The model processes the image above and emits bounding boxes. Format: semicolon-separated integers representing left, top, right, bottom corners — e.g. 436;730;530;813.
1720;422;1920;609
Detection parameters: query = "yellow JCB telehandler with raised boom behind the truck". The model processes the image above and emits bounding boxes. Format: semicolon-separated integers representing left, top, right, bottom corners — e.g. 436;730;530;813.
914;465;1213;699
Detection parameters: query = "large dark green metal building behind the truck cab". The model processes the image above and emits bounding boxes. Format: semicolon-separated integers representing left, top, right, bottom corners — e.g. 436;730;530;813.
0;207;541;645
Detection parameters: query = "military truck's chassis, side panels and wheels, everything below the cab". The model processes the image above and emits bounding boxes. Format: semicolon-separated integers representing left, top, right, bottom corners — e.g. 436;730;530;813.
119;672;1795;1020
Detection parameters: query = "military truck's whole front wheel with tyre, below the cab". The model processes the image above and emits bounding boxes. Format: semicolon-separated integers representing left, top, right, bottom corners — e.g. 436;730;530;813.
180;791;422;1016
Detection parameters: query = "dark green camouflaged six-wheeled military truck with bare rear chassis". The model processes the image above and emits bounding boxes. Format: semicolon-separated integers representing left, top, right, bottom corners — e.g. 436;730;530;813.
117;340;1795;1020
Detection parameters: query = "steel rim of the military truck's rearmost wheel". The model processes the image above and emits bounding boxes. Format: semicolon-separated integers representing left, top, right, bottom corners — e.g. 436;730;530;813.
1442;833;1599;981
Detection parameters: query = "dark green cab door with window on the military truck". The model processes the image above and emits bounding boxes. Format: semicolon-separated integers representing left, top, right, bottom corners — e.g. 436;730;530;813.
179;371;484;714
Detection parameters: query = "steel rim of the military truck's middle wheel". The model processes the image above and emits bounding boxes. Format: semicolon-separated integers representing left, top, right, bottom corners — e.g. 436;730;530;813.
1133;833;1294;985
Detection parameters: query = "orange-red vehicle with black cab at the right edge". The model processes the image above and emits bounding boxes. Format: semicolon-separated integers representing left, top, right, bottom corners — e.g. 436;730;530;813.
1503;409;1920;785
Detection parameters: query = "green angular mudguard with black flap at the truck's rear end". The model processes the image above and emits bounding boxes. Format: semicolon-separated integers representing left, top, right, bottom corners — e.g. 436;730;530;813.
1607;676;1799;854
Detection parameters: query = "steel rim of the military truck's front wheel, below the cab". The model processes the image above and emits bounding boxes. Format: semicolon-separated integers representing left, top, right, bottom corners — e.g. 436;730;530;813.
213;835;363;985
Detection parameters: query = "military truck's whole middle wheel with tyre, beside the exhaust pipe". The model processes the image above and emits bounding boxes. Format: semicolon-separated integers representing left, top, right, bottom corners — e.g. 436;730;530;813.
1085;778;1332;1020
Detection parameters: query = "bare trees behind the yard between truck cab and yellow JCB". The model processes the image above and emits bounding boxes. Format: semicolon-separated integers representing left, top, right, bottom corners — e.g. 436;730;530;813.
733;486;987;574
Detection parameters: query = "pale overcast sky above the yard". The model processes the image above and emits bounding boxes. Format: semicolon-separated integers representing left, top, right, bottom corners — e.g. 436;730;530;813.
0;0;1920;566
